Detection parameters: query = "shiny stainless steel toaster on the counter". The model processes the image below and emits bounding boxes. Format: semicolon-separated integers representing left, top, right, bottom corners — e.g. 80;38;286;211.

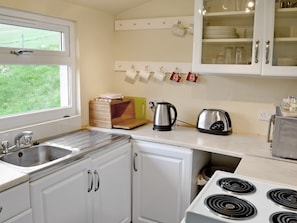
197;109;232;135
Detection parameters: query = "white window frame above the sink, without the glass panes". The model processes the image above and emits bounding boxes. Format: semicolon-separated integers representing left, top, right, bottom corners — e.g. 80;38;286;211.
0;7;80;131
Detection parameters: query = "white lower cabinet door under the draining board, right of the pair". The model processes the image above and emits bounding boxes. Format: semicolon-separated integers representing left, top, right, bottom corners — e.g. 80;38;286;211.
92;143;132;223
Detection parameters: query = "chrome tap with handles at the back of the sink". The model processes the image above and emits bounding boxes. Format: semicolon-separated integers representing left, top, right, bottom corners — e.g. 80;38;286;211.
1;131;33;154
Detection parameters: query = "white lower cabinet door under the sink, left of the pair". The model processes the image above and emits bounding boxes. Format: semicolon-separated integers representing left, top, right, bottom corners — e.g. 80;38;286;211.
30;159;92;223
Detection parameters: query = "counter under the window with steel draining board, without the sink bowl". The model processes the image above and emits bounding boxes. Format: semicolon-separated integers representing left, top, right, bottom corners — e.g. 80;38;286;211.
0;129;130;192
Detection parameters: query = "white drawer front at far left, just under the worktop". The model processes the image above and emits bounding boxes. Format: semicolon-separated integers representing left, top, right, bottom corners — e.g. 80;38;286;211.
0;182;30;222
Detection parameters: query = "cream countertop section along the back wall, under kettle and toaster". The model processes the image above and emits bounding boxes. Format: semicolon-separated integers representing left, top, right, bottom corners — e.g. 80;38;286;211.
91;124;272;158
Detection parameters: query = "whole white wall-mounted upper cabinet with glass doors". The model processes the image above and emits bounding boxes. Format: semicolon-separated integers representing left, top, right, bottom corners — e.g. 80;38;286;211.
193;0;297;77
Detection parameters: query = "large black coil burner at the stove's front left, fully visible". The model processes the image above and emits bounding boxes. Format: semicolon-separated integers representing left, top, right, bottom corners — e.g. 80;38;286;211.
205;194;257;220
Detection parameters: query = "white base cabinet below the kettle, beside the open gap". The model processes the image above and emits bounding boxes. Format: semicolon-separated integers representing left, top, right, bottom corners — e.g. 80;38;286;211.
132;140;208;223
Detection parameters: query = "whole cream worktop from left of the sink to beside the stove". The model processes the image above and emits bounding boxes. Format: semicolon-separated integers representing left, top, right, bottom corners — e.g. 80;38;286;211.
0;124;297;191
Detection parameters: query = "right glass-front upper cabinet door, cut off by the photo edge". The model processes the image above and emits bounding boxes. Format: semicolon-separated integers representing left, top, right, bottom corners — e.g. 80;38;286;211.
262;0;297;77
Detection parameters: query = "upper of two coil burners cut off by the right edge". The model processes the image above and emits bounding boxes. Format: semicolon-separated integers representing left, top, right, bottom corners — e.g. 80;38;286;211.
267;189;297;210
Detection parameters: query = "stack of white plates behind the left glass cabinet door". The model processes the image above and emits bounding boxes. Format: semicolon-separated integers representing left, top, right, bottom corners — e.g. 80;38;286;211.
204;26;238;39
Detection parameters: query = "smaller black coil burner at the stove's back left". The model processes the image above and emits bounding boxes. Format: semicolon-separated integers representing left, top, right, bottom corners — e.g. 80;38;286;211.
217;177;256;194
